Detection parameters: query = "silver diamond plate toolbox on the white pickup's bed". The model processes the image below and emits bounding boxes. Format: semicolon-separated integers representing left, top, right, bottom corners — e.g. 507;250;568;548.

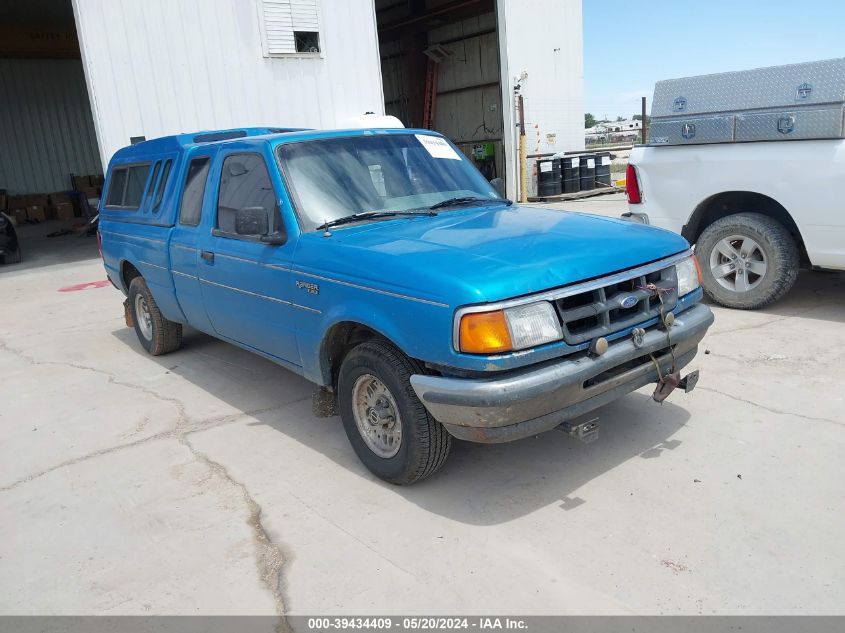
648;58;845;145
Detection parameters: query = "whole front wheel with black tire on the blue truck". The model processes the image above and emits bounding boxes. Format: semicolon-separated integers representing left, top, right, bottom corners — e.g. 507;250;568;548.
338;341;452;485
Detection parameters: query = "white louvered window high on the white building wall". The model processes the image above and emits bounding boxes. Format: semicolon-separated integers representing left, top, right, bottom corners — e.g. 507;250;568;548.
259;0;320;57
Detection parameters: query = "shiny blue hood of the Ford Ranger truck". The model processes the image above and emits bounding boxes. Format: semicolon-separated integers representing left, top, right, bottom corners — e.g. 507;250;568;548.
298;205;689;305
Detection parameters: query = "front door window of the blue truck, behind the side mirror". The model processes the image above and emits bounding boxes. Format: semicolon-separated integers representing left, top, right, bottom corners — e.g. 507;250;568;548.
217;154;280;235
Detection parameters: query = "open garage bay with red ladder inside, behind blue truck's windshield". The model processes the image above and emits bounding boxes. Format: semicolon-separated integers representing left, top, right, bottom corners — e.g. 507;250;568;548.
376;0;505;186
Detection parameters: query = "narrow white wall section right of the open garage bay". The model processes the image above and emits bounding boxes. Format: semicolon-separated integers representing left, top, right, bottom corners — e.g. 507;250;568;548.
497;0;584;196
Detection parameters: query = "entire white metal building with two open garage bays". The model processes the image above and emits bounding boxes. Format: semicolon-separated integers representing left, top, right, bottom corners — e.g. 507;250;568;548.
0;0;584;200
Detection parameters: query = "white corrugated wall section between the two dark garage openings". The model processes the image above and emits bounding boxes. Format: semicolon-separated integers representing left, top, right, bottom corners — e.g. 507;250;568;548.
73;0;384;164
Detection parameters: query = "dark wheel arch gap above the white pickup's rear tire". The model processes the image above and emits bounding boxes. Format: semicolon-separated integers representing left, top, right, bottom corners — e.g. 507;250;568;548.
681;191;808;262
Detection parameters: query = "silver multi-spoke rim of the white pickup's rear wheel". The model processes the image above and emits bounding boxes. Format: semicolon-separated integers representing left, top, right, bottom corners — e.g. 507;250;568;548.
710;235;769;293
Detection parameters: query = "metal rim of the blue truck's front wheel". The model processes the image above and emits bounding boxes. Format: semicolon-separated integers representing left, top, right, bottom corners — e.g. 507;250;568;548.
352;374;402;459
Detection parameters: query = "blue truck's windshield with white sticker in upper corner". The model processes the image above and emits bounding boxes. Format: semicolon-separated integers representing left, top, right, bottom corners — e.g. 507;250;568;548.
279;133;501;231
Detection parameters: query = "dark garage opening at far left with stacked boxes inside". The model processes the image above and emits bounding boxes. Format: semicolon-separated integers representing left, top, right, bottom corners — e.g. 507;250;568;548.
0;0;103;261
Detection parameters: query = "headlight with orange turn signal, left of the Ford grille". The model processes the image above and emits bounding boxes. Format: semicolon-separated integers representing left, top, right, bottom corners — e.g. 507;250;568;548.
459;301;563;354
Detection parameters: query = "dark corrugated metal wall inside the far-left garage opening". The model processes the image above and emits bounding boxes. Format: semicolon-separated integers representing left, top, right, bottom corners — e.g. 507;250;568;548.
0;59;102;194
